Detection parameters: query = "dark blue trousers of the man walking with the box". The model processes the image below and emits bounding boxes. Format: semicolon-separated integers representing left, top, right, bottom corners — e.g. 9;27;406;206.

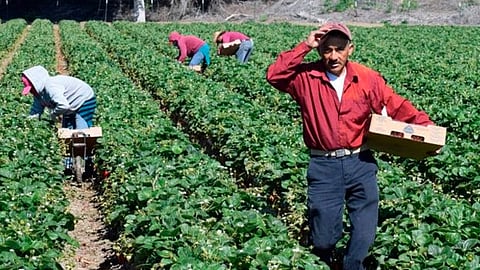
307;150;379;270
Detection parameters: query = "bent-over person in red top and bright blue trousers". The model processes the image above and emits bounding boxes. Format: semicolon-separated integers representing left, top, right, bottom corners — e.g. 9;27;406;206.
168;31;210;72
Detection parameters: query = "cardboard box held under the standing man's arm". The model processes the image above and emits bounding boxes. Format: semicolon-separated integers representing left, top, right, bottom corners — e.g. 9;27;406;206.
367;114;447;160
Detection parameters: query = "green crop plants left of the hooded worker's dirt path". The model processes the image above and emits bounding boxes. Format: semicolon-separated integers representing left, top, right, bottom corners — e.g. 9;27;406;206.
0;20;75;270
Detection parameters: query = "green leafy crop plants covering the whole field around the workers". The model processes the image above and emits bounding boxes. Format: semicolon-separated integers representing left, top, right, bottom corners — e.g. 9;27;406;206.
0;19;480;269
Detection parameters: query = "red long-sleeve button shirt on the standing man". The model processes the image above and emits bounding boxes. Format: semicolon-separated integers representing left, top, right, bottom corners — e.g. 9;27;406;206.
266;42;433;151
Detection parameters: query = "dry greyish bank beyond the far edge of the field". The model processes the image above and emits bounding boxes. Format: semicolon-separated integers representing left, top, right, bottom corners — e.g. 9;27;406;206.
168;0;480;26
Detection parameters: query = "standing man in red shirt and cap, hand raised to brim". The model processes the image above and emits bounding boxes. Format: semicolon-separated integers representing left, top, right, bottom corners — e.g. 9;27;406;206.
266;23;433;270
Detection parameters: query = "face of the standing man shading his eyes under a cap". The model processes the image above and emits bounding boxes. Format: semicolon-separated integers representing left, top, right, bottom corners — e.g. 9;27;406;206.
318;34;353;76
